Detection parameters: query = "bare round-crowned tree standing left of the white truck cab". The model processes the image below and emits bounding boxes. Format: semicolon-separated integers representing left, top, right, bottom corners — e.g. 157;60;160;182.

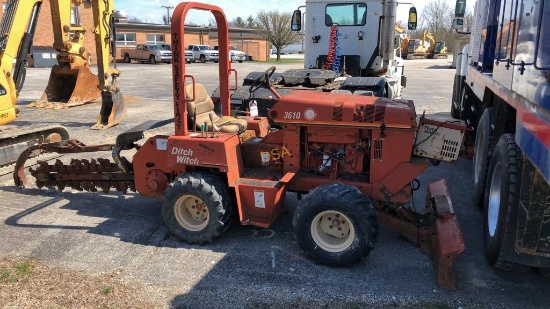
255;11;300;61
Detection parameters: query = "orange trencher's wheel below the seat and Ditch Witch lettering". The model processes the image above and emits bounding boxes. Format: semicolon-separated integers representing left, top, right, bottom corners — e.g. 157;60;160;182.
162;173;233;245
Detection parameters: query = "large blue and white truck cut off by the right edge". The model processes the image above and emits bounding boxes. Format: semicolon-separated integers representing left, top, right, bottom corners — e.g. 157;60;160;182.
451;0;550;276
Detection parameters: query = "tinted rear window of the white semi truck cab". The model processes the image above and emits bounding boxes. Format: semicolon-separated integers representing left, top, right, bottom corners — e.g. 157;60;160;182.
325;3;367;27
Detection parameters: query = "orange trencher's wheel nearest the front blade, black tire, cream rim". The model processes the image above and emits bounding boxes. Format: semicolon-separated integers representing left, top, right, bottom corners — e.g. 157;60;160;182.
292;183;379;266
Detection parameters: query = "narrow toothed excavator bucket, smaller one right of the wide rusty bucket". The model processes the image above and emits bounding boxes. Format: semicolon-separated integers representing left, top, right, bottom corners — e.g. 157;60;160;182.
92;89;126;130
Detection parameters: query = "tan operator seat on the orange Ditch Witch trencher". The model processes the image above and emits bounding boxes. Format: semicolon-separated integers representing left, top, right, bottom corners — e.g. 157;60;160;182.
185;83;247;134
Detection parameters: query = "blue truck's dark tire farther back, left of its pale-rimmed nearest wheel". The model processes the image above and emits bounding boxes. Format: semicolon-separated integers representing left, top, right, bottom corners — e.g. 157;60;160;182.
472;107;494;207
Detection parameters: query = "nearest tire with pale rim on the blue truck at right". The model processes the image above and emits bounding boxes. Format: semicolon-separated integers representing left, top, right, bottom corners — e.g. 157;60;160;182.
483;134;530;272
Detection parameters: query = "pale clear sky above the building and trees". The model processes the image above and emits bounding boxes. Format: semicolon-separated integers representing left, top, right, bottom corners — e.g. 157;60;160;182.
115;0;466;25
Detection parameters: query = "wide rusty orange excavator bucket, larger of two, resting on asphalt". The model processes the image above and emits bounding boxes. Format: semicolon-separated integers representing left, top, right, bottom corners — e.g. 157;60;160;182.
28;65;101;109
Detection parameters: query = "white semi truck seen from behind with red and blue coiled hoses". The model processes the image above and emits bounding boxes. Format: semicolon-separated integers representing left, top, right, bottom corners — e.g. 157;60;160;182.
224;0;416;116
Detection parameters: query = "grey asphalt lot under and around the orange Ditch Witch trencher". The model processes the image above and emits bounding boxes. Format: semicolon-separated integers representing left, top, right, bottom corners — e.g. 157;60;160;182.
0;59;550;308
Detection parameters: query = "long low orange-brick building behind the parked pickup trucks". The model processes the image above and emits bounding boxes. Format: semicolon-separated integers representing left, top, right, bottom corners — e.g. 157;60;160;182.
0;0;270;63
